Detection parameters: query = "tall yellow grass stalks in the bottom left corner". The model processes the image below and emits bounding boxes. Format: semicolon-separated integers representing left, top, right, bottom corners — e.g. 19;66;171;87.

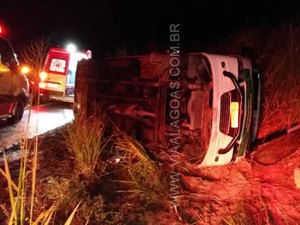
0;111;80;225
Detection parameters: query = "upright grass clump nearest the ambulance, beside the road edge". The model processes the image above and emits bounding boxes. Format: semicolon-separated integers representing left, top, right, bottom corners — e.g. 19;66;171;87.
66;111;109;179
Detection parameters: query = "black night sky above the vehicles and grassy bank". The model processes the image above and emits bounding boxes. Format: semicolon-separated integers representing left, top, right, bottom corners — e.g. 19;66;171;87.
0;0;300;58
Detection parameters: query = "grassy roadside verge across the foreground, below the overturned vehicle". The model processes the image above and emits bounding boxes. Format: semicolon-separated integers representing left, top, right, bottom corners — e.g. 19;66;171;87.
0;108;300;225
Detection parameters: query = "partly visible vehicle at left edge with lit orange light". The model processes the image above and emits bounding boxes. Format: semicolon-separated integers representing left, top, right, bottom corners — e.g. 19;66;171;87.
0;37;29;124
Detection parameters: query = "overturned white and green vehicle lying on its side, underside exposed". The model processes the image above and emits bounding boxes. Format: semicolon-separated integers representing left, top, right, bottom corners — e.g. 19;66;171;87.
74;52;260;166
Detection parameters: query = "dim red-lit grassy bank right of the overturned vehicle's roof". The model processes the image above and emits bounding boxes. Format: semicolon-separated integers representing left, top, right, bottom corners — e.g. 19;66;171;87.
255;24;300;136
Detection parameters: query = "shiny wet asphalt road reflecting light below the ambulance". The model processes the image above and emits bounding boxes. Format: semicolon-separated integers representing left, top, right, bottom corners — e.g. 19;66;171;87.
0;102;73;151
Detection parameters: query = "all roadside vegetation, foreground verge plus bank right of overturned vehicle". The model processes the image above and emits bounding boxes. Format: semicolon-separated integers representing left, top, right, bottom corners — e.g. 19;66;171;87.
0;20;300;225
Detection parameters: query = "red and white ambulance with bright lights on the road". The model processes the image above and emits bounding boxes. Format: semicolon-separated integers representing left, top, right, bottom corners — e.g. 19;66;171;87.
39;46;92;103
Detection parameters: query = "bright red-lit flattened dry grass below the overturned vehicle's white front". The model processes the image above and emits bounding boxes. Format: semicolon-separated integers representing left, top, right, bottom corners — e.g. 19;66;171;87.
179;156;300;225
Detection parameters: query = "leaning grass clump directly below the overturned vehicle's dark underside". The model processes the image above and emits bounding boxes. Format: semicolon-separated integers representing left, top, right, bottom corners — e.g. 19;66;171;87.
115;134;168;205
